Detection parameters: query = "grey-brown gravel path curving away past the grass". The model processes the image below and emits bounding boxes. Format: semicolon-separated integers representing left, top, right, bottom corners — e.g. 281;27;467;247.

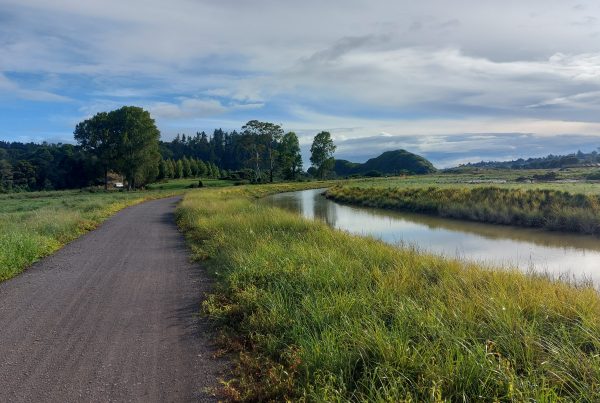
0;198;224;402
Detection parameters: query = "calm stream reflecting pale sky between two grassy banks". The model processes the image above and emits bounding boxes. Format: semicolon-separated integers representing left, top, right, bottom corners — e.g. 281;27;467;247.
265;189;600;284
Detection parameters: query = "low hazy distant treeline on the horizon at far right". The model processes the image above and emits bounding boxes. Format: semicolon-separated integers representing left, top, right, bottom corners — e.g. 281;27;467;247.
460;151;600;169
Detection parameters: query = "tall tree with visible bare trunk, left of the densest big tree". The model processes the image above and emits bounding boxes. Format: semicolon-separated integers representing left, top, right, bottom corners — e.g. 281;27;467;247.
73;112;119;189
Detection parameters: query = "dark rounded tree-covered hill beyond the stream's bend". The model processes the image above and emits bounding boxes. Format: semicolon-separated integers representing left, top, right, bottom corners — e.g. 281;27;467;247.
334;150;436;176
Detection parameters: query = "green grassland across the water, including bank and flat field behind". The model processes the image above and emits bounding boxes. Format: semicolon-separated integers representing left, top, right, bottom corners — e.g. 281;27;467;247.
327;174;600;234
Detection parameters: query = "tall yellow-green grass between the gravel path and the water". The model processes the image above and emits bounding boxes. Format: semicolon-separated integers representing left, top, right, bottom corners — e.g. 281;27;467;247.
177;186;600;401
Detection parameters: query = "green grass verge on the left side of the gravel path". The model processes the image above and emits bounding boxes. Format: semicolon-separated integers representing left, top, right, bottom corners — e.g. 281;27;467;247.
0;189;188;281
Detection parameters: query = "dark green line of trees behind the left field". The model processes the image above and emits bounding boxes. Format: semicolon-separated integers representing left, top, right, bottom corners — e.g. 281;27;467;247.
0;106;335;192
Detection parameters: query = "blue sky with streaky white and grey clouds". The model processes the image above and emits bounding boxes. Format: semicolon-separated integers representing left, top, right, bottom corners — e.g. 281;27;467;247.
0;0;600;167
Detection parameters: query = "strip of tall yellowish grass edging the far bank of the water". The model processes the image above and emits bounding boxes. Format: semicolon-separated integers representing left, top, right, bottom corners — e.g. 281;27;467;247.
327;186;600;234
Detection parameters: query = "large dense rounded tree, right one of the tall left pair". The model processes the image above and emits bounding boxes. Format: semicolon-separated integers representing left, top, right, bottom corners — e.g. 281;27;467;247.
109;106;160;189
